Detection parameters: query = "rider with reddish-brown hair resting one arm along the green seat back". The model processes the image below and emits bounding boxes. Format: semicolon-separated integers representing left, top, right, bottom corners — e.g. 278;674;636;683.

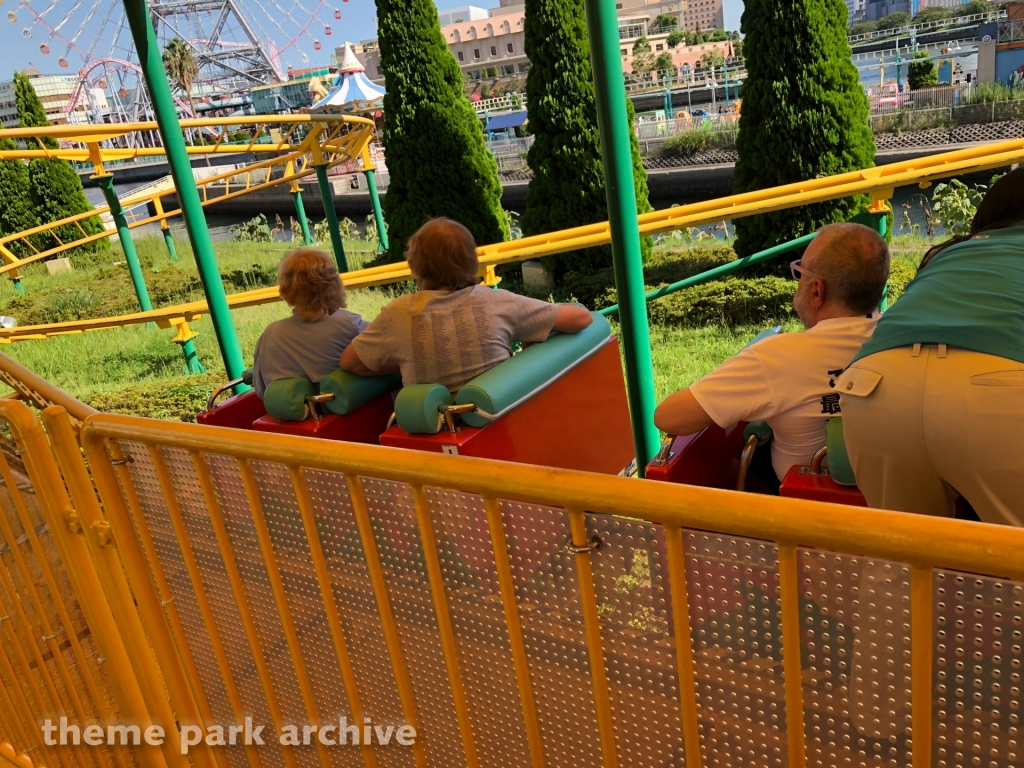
341;218;593;391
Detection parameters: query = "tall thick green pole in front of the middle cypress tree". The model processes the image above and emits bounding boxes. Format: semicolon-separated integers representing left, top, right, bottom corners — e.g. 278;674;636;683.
585;0;659;477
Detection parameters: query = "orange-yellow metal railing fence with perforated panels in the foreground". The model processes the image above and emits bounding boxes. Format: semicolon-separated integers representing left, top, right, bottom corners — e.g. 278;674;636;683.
0;402;1024;768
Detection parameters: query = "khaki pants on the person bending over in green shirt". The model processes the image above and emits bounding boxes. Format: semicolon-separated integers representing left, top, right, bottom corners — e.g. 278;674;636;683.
836;344;1024;525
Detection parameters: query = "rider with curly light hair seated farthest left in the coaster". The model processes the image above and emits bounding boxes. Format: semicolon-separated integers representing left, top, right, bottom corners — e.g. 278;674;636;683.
253;248;369;397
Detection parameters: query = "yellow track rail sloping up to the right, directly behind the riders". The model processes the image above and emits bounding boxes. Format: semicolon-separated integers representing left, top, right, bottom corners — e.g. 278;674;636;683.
0;139;1024;344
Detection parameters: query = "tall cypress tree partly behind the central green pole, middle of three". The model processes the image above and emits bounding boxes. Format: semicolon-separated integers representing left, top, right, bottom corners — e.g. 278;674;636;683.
520;0;651;278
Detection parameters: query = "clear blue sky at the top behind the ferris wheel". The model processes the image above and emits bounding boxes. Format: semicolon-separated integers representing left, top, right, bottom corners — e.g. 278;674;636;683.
0;0;743;80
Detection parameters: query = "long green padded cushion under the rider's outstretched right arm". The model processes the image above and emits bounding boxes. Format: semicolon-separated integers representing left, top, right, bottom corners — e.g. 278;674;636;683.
456;313;611;434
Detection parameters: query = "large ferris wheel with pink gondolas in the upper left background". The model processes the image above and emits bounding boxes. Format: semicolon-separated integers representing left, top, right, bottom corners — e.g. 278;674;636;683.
7;0;349;128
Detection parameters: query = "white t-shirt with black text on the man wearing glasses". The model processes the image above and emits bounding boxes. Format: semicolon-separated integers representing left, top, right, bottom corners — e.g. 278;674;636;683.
690;317;878;479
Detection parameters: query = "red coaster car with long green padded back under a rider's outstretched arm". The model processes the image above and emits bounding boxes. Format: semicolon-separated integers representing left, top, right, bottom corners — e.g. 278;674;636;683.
380;314;634;474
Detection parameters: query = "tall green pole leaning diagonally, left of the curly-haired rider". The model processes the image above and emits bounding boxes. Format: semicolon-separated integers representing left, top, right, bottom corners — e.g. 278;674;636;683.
118;0;248;391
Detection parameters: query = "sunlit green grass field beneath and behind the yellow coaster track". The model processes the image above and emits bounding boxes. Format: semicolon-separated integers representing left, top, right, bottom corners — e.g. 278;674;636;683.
0;238;927;419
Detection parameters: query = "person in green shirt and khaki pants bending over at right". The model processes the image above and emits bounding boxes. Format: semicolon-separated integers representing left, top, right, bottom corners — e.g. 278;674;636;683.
836;168;1024;525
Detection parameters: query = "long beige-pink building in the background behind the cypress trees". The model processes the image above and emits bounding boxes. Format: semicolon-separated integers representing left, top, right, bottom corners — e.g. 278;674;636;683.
346;0;732;83
